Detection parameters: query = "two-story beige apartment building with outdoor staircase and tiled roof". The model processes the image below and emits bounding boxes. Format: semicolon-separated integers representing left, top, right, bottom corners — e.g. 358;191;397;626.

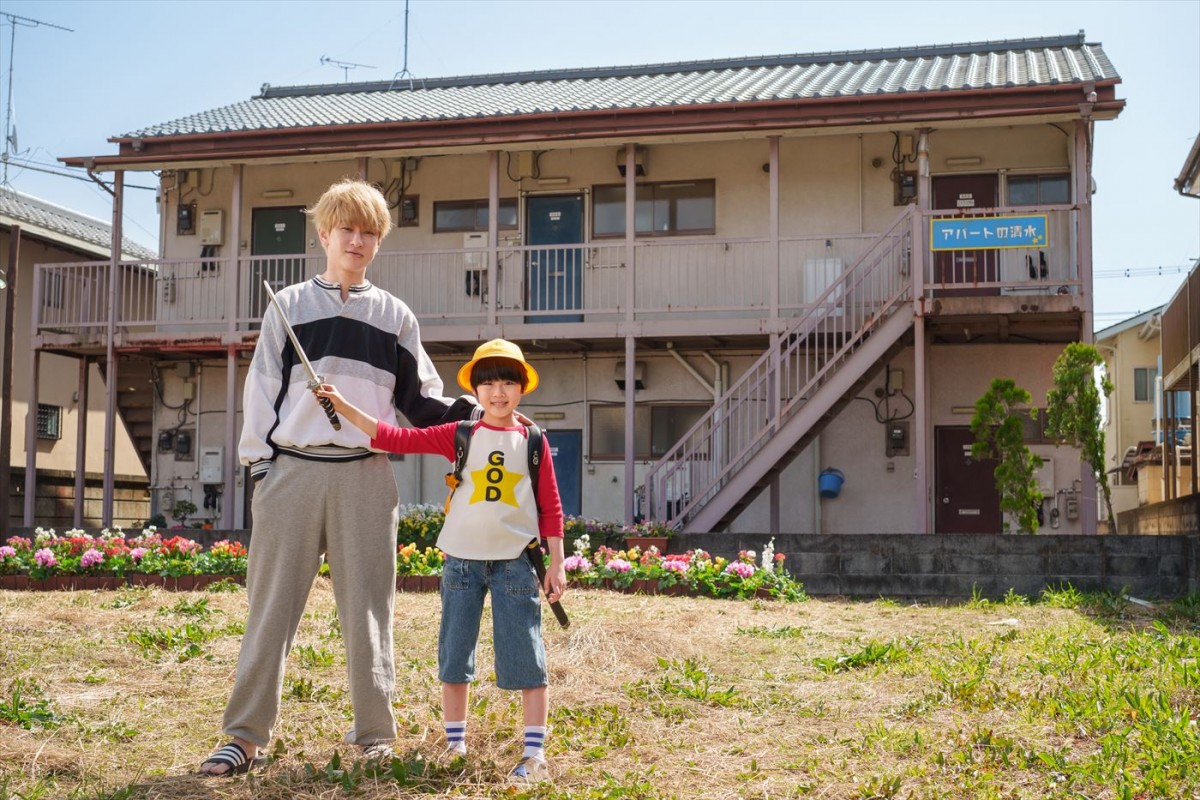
37;34;1123;533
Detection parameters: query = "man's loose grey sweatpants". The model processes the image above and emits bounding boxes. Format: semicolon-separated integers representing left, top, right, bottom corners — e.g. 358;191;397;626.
224;455;398;747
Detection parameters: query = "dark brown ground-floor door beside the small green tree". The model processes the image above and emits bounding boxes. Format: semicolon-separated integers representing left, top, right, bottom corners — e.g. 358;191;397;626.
934;427;1001;534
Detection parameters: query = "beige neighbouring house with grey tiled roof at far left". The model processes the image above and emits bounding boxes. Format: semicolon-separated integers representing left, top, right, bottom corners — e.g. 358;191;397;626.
0;186;155;530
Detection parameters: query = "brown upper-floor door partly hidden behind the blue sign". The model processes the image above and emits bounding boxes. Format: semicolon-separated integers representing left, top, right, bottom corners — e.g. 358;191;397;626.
932;175;1000;297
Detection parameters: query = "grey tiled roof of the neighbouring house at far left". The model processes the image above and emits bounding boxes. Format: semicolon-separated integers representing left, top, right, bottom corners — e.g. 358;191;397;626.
0;186;158;260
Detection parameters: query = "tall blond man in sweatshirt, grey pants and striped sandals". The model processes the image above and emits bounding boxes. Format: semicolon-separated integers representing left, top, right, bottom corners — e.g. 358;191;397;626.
200;180;479;775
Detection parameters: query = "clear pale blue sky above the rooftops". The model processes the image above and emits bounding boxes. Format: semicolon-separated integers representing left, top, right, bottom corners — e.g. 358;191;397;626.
0;0;1200;329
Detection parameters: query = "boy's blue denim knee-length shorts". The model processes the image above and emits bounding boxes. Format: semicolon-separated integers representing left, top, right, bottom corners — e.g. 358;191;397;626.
438;555;547;690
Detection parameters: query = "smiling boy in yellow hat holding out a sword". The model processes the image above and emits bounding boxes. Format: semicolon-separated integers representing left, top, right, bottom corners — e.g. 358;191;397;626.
314;339;566;784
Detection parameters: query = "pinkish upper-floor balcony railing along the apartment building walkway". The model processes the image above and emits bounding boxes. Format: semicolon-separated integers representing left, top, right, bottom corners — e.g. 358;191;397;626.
35;206;1079;341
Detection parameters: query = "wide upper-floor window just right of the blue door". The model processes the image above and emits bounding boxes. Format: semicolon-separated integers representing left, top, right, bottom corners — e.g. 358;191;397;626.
592;180;716;239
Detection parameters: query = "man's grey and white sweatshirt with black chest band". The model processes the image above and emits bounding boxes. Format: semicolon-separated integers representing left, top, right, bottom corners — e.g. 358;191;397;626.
238;277;479;480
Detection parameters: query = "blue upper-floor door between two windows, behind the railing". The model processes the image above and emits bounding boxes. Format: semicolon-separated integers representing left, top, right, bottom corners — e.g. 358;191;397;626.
526;194;583;323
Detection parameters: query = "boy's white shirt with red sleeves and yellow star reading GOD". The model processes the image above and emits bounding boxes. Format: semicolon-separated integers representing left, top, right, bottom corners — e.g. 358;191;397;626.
371;422;563;561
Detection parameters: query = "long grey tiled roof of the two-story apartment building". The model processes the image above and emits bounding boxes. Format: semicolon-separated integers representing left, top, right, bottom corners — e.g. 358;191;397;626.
122;31;1120;138
